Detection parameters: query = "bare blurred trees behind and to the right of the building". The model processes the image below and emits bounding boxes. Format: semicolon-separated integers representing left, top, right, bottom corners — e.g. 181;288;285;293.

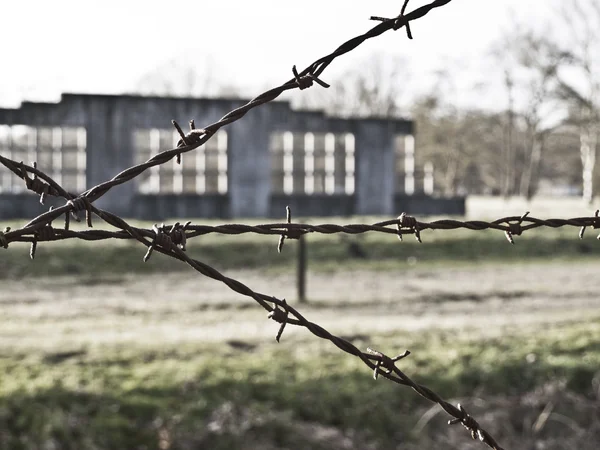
139;0;600;202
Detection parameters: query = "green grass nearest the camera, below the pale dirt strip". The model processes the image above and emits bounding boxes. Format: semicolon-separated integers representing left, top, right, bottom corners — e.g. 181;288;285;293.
0;320;600;450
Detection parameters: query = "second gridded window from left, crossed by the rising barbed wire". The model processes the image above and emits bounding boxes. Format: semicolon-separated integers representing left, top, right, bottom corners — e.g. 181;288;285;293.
134;128;227;194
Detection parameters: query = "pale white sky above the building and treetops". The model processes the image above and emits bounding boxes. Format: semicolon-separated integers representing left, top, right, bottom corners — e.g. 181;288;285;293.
0;0;547;107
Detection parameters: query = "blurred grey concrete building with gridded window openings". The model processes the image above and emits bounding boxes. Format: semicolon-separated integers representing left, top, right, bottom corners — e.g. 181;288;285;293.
0;94;464;220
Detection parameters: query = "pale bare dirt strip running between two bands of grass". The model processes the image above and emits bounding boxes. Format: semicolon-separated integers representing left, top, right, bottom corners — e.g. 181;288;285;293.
0;262;600;351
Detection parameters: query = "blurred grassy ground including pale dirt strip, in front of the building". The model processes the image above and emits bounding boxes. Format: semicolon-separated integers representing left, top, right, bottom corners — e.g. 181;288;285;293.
0;216;600;450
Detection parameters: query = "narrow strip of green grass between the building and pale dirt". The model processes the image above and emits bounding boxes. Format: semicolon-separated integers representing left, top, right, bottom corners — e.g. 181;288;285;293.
0;218;600;278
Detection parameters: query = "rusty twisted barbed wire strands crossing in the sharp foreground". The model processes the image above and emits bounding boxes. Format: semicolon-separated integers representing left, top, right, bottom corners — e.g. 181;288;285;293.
0;0;600;450
